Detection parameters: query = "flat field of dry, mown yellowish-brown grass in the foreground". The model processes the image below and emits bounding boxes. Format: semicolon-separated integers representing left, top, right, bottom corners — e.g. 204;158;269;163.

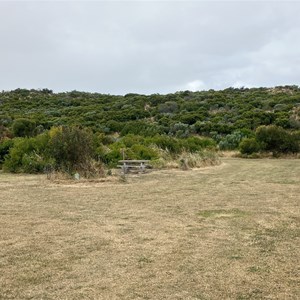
0;158;300;300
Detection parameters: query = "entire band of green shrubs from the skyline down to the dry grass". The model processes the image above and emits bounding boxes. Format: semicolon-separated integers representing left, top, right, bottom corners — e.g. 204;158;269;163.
0;86;300;172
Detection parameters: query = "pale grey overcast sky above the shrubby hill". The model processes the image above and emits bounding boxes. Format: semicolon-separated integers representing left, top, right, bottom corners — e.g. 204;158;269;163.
0;0;300;95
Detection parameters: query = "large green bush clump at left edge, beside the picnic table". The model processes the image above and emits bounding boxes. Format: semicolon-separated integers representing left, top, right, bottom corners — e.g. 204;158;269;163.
0;127;94;173
